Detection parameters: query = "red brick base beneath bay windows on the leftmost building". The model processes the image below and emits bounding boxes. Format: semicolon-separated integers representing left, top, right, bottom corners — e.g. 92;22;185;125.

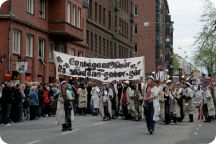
49;21;84;41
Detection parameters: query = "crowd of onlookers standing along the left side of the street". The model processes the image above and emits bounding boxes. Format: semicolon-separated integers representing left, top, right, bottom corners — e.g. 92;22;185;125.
0;82;61;125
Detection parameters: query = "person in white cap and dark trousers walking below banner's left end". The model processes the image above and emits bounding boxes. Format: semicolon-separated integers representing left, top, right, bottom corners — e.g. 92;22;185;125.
61;81;73;131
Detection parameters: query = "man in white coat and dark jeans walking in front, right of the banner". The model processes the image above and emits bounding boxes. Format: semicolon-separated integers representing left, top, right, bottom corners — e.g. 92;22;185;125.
144;76;159;134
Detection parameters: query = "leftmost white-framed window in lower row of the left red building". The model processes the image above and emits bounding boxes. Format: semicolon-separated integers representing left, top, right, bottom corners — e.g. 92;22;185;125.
13;30;21;54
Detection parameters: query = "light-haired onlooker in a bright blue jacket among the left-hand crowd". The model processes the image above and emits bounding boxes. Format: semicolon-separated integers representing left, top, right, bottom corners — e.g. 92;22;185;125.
29;86;39;120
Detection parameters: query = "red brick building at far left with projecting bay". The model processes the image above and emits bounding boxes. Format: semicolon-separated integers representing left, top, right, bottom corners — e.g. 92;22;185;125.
0;0;86;82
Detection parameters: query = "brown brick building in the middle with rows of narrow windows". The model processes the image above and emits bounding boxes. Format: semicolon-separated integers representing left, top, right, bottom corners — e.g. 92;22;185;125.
86;0;133;58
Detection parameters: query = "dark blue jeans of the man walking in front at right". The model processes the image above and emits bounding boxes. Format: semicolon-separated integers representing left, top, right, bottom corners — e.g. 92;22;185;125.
144;102;155;132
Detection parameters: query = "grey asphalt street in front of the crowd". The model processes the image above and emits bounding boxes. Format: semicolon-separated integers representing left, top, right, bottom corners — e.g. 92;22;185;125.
0;116;216;144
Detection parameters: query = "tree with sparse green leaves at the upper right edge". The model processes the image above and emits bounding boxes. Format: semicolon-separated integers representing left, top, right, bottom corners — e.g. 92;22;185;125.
194;0;216;74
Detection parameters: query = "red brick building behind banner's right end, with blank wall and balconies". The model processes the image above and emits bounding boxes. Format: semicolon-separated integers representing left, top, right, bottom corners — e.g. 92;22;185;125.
132;0;173;74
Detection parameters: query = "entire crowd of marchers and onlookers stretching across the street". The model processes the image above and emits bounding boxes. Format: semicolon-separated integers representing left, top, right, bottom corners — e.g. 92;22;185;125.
0;76;216;134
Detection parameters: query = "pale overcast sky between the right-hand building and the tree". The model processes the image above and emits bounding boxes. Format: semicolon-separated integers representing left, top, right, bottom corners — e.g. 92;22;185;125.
168;0;216;63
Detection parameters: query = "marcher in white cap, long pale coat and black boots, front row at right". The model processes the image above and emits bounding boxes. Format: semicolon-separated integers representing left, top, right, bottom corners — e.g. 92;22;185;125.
184;82;194;122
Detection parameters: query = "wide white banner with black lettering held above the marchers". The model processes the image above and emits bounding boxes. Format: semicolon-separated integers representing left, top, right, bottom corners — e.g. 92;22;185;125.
54;52;145;82
